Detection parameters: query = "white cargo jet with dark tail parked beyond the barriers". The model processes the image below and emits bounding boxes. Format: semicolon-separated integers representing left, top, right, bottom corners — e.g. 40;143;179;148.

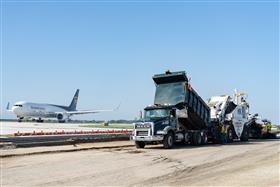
7;89;118;123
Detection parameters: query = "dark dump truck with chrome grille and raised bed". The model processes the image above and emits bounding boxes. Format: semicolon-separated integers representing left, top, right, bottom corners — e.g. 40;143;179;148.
132;71;219;148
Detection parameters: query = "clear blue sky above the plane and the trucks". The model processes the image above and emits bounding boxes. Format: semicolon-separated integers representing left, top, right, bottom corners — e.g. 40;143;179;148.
1;1;279;123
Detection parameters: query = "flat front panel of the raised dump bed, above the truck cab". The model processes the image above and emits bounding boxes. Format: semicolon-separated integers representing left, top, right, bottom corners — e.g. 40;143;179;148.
155;82;185;105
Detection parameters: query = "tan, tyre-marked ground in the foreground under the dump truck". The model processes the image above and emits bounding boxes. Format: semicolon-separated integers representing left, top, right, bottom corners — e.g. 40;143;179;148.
1;140;280;187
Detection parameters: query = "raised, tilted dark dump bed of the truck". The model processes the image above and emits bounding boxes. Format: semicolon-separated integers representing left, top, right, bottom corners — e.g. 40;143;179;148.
153;71;211;130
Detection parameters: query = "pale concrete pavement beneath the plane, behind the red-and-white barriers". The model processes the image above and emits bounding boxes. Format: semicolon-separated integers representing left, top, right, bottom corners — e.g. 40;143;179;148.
0;121;128;136
